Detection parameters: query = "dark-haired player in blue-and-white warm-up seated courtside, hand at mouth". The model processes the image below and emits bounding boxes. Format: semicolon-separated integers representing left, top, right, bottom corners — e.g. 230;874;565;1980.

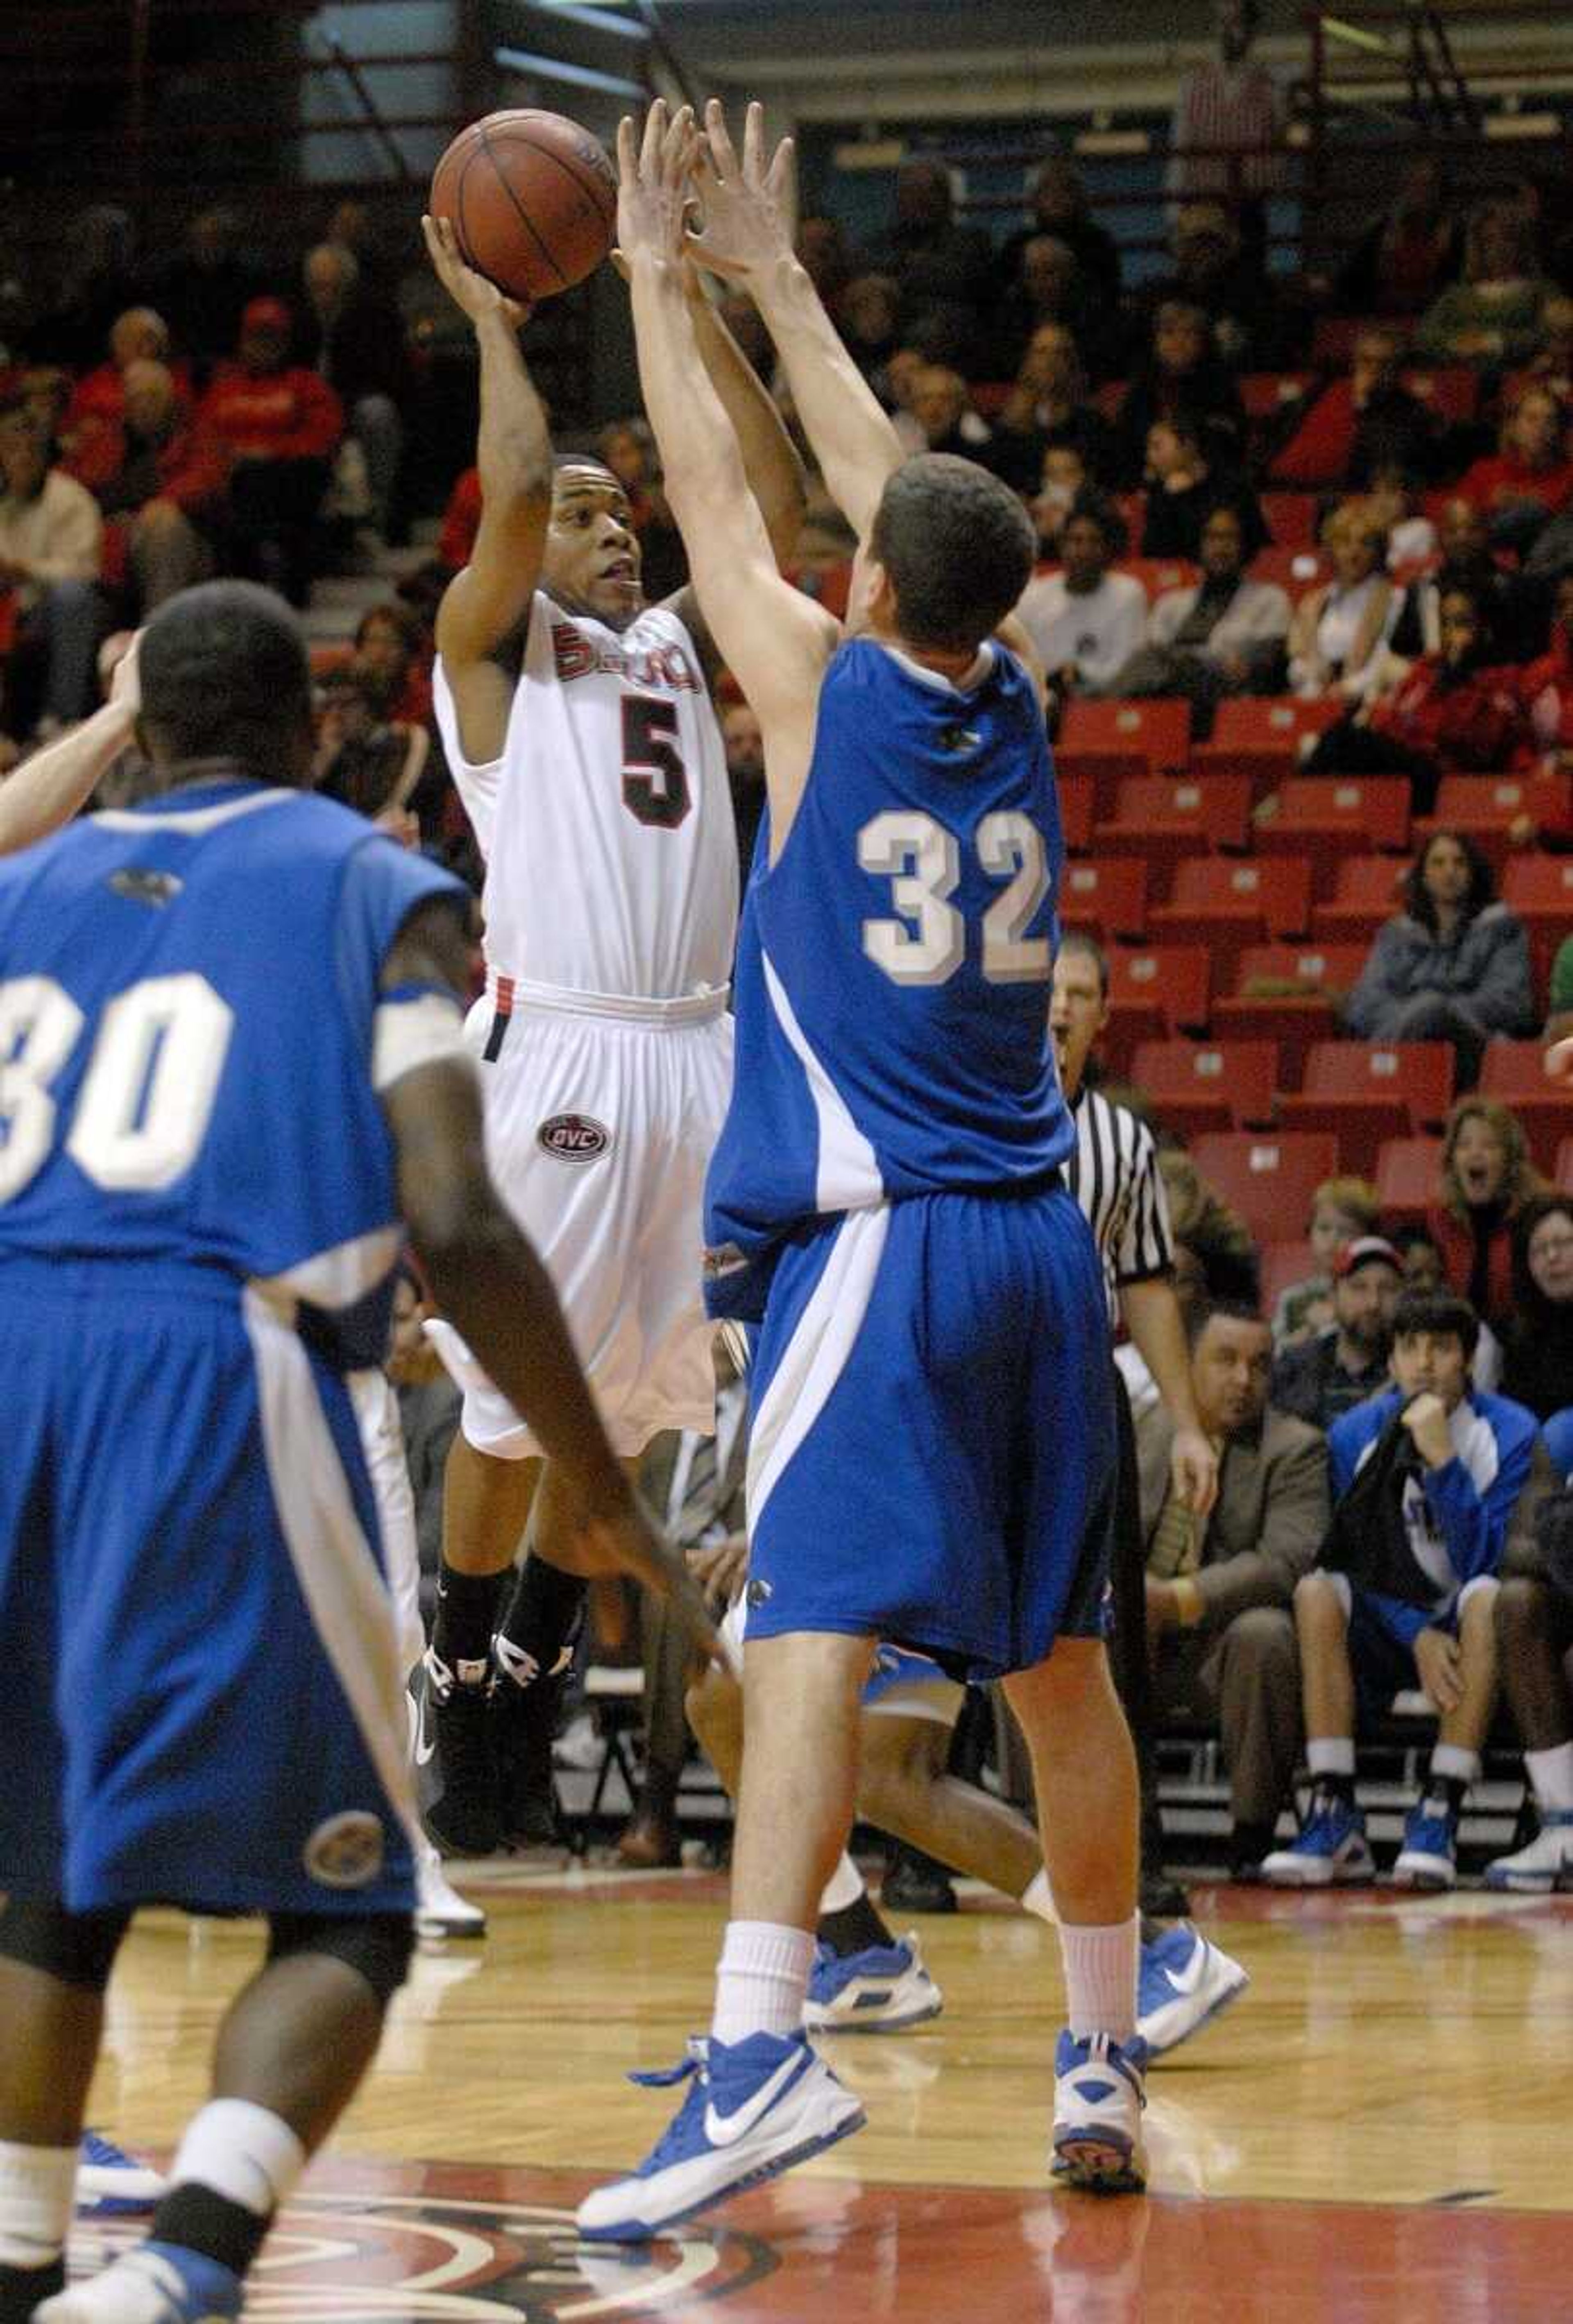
1262;1292;1536;1890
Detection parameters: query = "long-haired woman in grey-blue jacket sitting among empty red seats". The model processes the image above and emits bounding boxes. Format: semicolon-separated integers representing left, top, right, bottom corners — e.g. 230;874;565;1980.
1343;832;1534;1090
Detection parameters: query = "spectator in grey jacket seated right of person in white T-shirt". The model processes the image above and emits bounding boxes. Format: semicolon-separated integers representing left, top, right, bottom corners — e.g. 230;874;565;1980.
1113;500;1290;704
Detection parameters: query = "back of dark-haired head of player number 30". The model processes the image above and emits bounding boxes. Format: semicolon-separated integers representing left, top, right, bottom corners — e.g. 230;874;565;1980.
137;581;311;785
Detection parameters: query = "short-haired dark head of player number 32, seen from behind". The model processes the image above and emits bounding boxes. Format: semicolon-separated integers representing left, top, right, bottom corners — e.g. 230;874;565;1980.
869;451;1038;653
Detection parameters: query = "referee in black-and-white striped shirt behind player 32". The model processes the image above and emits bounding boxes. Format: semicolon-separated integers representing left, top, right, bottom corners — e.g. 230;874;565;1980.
1048;930;1217;1915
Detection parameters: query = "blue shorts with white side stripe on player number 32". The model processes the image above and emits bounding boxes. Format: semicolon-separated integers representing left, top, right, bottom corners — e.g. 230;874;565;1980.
748;1188;1115;1680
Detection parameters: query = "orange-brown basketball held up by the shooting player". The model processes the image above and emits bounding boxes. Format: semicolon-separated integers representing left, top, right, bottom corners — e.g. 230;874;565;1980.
430;107;618;300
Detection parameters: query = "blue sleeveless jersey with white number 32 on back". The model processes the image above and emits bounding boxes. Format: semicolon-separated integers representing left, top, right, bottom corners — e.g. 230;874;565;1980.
706;639;1076;1283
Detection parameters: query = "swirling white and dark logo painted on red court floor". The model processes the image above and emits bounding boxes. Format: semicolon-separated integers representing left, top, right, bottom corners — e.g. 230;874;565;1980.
70;2194;776;2324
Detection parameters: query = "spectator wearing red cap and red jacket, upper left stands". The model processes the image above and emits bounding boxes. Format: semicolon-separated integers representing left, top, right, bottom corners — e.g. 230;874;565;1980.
197;297;344;604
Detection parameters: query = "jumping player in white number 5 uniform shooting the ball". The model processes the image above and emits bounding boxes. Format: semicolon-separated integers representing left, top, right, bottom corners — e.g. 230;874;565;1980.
416;218;802;1855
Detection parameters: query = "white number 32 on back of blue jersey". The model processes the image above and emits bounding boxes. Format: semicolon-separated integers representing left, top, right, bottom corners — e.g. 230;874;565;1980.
857;809;1050;985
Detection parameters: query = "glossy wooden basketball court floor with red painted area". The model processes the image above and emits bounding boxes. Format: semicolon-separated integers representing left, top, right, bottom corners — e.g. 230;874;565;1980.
86;1864;1573;2324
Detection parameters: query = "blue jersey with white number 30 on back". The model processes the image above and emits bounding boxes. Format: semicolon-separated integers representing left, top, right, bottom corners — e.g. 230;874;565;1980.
0;778;458;1362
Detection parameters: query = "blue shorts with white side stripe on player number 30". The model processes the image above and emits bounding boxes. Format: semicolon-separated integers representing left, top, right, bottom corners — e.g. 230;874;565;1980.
0;1262;414;1913
